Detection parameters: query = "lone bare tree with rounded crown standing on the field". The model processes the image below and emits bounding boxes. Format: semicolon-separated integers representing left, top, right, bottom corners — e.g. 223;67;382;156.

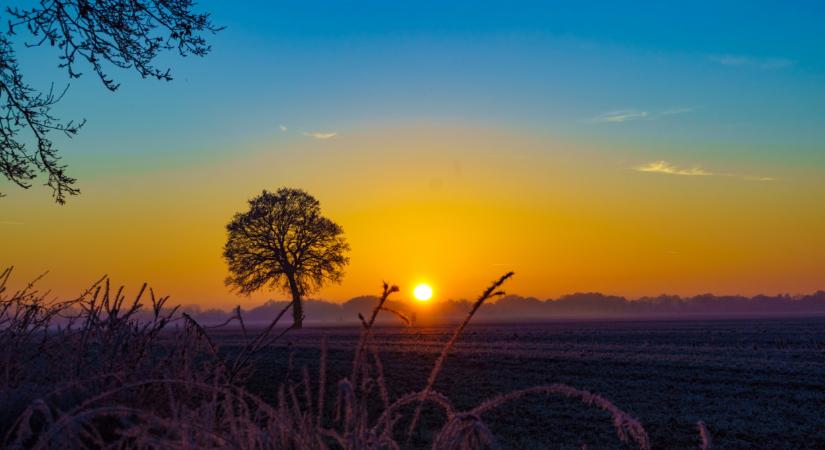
223;188;349;328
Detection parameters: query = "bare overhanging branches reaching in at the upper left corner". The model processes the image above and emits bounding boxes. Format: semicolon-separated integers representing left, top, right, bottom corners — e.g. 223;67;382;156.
0;0;219;204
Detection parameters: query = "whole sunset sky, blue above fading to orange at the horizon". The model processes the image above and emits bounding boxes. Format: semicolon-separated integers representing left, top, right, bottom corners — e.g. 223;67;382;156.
0;0;825;306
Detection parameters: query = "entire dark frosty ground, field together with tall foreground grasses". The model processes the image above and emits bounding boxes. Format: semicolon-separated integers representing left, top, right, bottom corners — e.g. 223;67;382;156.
0;271;825;450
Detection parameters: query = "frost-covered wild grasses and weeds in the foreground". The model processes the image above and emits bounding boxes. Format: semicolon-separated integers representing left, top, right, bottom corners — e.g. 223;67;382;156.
0;270;710;449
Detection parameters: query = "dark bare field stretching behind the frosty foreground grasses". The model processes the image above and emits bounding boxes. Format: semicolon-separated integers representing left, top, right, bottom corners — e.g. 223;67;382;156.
217;318;825;449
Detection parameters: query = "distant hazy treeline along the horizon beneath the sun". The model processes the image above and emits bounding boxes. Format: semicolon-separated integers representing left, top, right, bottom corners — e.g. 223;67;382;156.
184;291;825;324
